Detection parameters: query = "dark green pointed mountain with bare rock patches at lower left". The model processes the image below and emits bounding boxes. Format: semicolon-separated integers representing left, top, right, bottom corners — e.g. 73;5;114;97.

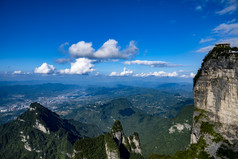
0;103;101;159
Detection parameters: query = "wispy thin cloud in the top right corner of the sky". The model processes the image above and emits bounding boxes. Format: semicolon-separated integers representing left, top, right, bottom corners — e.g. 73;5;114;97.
216;0;238;15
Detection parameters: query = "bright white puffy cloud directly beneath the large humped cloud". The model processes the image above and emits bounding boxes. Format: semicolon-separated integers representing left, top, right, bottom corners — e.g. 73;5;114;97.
59;58;94;75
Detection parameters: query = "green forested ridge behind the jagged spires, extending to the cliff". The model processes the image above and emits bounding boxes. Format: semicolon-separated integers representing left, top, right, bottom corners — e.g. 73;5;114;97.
63;98;193;157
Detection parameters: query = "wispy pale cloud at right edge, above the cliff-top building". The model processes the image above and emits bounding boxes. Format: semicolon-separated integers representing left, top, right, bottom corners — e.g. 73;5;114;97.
213;23;238;35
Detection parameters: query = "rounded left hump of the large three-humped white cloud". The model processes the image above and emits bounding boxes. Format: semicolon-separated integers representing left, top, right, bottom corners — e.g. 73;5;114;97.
69;41;95;58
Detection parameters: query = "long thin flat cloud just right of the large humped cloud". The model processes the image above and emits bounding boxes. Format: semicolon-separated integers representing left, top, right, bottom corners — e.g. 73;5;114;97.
124;60;182;67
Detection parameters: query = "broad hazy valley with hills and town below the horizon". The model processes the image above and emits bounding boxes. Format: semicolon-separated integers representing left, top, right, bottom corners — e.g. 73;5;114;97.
0;84;193;158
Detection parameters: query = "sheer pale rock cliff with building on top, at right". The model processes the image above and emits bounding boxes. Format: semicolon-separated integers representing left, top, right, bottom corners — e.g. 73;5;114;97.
191;47;238;158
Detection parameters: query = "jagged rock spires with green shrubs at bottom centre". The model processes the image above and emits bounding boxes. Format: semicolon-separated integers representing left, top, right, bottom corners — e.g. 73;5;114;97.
74;120;143;159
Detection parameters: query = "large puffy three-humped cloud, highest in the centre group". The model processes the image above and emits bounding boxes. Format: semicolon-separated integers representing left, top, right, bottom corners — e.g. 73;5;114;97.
69;39;138;59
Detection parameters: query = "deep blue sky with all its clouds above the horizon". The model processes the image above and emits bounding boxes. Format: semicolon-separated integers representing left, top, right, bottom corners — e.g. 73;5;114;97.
0;0;238;80
